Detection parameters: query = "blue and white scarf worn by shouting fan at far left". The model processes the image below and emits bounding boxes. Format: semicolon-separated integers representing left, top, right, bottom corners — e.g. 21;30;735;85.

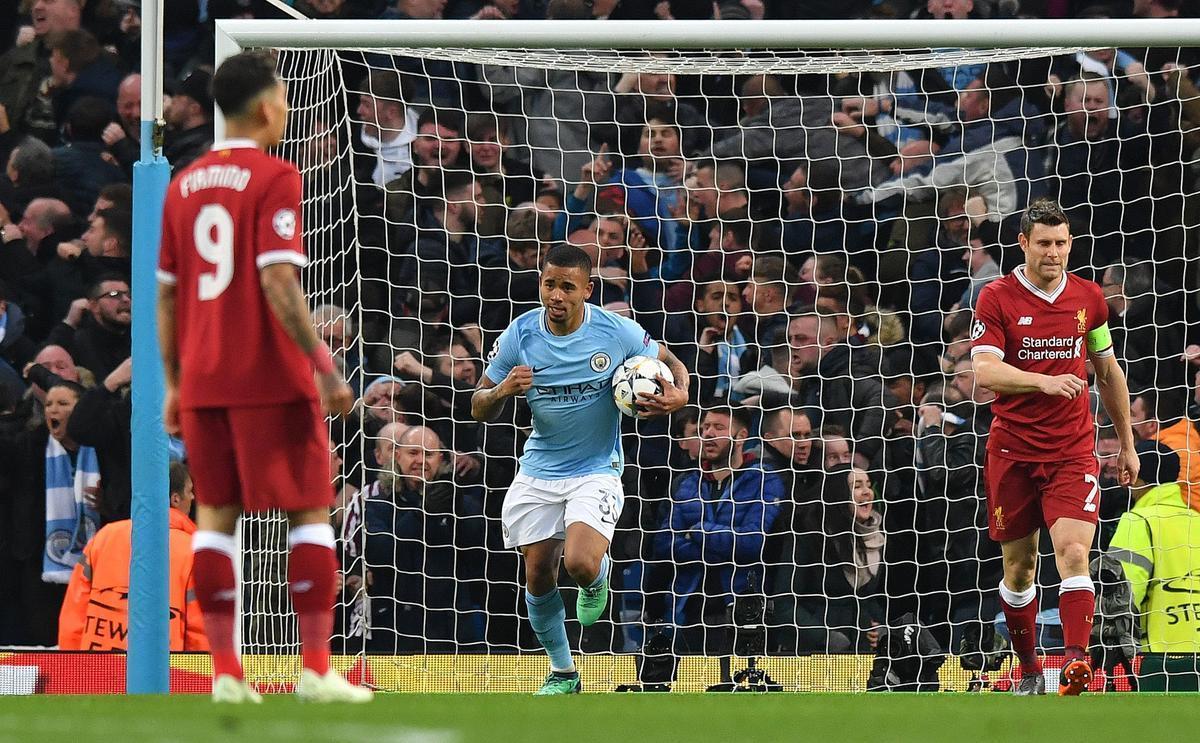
42;436;100;583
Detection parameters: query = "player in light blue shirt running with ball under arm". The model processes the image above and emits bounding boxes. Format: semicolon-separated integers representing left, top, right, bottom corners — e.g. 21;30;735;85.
470;245;688;695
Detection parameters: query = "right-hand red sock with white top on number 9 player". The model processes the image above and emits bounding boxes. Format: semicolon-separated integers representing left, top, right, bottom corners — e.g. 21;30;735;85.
288;523;337;676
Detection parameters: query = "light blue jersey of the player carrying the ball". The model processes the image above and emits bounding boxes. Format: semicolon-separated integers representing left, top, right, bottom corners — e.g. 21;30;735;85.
484;305;659;480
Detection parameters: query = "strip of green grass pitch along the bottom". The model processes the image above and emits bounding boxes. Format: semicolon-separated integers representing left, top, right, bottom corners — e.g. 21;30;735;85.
0;693;1200;743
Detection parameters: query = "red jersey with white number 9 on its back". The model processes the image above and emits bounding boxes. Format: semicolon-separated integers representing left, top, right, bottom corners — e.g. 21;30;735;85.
158;139;317;408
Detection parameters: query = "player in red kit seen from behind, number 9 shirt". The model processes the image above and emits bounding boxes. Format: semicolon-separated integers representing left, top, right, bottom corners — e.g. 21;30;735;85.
158;52;372;703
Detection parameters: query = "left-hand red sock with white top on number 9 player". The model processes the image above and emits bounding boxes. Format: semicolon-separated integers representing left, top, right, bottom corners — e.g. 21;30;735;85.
192;532;242;679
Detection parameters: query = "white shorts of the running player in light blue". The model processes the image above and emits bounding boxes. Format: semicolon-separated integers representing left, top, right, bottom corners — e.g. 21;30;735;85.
500;473;625;549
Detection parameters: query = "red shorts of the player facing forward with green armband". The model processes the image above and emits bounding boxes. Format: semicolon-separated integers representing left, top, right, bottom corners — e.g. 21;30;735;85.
984;451;1100;541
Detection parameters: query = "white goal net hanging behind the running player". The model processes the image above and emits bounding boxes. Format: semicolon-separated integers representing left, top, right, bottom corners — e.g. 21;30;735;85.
229;23;1200;691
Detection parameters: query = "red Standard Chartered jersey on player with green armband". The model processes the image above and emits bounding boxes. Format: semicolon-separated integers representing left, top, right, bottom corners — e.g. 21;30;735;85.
971;266;1112;462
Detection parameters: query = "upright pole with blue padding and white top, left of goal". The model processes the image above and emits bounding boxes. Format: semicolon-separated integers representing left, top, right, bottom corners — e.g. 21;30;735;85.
125;2;170;694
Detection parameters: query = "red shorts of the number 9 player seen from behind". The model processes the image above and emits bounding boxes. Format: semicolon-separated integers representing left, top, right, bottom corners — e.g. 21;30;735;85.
180;400;334;511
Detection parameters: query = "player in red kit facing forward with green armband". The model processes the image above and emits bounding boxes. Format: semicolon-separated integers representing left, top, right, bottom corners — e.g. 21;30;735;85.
971;199;1138;696
